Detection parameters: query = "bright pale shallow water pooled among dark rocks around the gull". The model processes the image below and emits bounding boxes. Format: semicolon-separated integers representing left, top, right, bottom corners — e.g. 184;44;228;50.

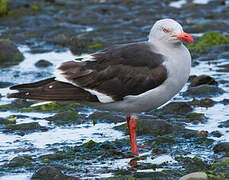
0;43;229;180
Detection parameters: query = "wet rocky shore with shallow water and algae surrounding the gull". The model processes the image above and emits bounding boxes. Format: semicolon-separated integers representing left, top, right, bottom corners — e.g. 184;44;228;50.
0;0;229;180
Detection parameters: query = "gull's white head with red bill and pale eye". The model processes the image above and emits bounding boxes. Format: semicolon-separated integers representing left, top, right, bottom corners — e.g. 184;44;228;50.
149;19;194;43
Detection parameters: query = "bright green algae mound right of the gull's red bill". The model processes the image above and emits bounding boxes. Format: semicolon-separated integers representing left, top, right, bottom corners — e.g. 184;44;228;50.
187;31;229;54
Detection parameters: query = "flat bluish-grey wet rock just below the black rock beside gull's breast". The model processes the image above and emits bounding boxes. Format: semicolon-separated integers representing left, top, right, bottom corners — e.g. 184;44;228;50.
183;84;223;97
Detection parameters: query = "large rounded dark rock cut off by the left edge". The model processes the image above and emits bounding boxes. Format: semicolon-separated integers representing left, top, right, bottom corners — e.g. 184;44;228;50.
0;40;23;67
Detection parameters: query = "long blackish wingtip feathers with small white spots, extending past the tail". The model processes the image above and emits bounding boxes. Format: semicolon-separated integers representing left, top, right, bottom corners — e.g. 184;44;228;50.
7;78;99;102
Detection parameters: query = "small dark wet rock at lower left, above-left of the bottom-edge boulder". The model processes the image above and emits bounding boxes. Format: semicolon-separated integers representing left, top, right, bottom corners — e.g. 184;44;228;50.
8;156;33;167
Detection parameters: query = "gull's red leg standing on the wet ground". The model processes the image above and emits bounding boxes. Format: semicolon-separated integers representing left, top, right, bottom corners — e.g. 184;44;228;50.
126;116;139;155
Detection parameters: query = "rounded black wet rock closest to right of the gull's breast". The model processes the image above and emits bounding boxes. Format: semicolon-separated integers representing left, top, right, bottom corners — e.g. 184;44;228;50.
190;75;217;87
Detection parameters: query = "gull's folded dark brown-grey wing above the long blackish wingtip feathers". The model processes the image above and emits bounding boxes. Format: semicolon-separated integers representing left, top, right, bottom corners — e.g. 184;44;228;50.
58;43;167;101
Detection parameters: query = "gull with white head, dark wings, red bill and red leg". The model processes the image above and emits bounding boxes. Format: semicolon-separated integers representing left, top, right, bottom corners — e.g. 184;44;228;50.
8;18;194;156
